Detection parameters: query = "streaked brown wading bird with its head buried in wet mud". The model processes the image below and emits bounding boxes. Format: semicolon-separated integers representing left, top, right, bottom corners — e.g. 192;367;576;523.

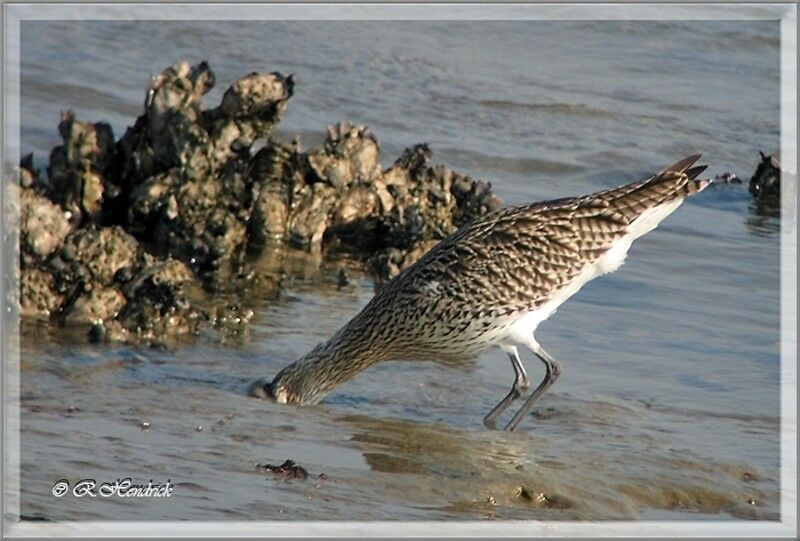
254;155;710;429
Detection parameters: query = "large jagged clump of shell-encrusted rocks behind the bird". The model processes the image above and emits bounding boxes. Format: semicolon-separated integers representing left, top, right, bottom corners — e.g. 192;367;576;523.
18;62;499;342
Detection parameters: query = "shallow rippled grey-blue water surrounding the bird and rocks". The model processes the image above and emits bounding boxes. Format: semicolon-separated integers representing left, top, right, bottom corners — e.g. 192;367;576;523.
21;21;780;520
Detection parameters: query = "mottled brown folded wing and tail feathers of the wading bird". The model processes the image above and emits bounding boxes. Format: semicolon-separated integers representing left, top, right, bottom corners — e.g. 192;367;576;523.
372;155;707;334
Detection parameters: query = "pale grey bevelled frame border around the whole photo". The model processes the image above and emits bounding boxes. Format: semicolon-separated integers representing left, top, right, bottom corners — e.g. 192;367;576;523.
0;3;797;538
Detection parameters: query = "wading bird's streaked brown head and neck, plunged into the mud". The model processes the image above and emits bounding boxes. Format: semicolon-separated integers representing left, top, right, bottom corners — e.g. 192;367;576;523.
271;320;384;404
